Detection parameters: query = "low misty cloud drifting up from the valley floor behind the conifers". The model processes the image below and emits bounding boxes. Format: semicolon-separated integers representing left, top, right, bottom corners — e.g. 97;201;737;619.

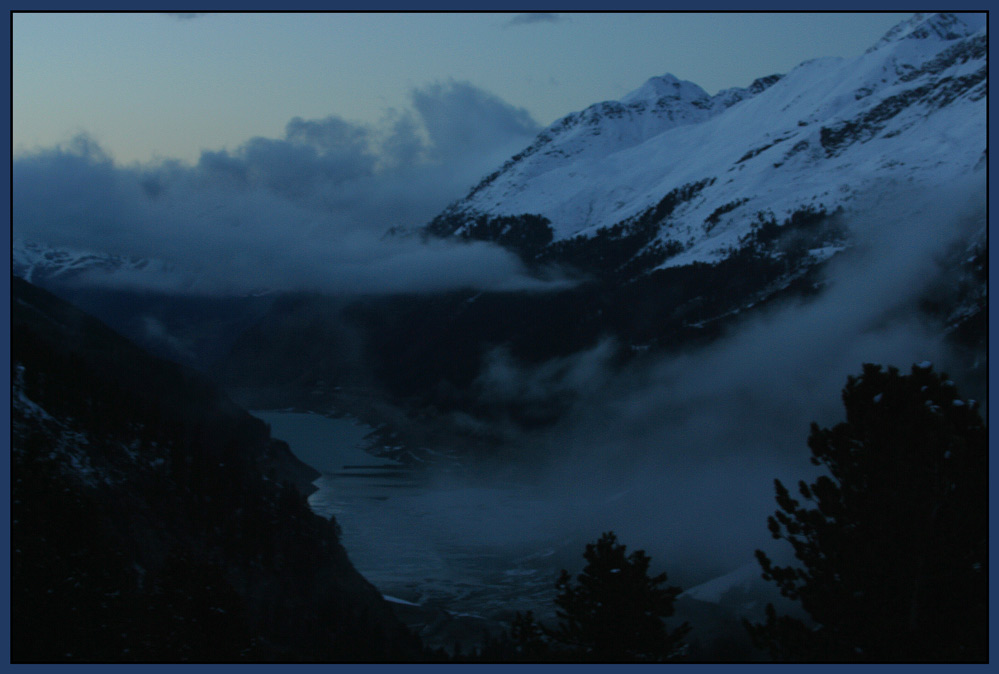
436;172;987;587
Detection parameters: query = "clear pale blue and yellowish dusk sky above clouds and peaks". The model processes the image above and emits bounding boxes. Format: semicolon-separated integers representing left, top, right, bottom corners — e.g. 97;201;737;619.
12;13;910;162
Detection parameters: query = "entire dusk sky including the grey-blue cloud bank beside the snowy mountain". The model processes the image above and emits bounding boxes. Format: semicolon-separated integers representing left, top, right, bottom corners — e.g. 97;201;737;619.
12;13;928;294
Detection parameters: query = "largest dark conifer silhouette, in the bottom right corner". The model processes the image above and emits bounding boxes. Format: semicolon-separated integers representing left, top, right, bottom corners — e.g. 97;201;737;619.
747;363;988;662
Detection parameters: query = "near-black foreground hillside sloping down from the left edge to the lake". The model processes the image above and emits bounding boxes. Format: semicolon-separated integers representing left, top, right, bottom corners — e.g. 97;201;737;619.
11;278;420;662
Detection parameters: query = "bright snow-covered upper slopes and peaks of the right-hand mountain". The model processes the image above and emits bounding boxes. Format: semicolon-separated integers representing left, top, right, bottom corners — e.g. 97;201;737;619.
429;14;988;270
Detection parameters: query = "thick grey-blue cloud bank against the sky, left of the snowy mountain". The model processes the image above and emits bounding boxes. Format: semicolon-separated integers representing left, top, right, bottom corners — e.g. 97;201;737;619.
13;82;556;293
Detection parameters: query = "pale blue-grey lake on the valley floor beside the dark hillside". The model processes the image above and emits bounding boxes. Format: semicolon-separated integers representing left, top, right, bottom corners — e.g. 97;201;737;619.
253;412;790;652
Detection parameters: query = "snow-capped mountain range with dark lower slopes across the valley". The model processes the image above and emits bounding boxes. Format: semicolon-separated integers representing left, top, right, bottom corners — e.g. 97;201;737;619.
13;14;988;434
